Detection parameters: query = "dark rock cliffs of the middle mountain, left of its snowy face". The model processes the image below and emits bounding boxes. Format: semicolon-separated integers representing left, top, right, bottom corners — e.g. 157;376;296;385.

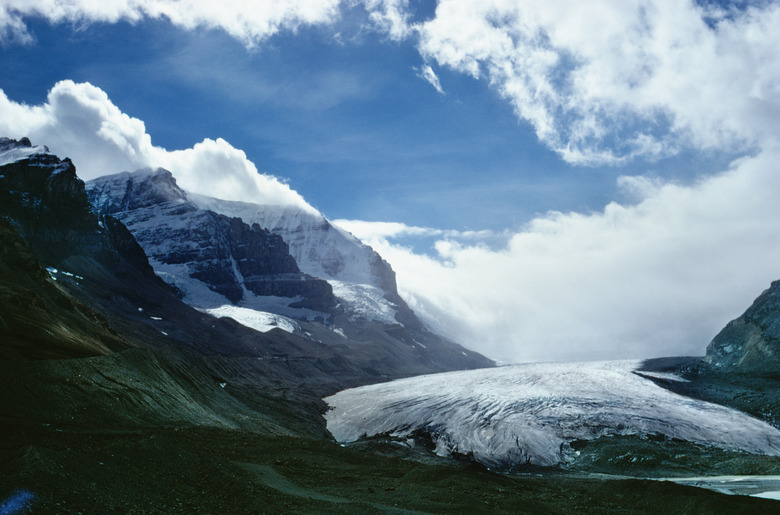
88;169;336;311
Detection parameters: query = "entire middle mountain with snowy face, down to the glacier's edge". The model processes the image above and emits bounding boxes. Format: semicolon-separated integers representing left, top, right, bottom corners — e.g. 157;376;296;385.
87;169;493;372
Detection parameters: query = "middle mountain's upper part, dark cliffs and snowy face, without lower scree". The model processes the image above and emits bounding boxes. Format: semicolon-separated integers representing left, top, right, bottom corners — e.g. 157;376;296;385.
87;169;419;325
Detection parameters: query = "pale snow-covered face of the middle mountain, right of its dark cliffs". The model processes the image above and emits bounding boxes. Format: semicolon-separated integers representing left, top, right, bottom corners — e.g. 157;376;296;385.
188;193;398;324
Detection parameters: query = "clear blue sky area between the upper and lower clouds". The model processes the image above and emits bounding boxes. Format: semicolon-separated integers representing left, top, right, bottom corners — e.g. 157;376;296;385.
0;9;731;231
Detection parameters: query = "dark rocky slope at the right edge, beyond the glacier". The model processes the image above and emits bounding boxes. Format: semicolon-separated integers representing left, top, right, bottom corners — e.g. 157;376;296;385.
705;281;780;372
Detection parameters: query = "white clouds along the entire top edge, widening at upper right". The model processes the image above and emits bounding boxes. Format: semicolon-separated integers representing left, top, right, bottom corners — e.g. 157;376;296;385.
0;0;780;164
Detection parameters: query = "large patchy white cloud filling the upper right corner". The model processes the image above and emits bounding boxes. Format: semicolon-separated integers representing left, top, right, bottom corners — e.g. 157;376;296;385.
416;0;780;164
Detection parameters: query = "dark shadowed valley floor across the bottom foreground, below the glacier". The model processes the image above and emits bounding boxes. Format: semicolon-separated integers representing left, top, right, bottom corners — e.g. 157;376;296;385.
0;420;777;513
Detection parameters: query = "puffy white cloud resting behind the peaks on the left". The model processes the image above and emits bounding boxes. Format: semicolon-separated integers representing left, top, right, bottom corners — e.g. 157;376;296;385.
0;80;314;212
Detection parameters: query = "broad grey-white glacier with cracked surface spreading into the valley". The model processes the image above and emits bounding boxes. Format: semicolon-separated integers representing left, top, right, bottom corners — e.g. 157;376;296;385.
325;361;780;468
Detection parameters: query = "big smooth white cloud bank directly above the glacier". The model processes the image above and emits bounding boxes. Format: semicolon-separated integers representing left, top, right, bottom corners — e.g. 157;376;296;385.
353;152;780;361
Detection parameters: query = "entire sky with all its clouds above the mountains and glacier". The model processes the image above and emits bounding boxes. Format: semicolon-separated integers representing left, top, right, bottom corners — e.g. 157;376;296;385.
0;0;780;361
